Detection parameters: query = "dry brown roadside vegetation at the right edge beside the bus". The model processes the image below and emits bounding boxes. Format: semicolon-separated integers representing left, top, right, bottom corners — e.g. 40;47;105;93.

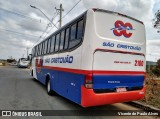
141;59;160;108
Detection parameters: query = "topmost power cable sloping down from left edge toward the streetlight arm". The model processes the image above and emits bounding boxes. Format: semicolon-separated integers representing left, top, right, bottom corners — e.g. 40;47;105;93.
0;8;46;23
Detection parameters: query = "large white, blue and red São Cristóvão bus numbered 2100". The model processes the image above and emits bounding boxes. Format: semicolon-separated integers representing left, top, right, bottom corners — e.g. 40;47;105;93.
31;9;146;107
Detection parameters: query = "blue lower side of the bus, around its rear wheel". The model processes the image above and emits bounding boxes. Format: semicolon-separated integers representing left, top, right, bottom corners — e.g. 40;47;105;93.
37;68;85;104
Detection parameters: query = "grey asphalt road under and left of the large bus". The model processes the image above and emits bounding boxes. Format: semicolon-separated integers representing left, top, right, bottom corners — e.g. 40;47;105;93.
0;66;155;119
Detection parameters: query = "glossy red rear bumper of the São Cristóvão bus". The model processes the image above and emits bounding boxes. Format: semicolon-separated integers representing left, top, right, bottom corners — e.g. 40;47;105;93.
81;86;145;107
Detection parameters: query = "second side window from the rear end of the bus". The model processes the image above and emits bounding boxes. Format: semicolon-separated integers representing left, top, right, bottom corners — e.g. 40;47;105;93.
69;24;77;48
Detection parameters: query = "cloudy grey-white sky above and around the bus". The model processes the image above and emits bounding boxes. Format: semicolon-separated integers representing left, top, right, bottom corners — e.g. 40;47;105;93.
0;0;160;61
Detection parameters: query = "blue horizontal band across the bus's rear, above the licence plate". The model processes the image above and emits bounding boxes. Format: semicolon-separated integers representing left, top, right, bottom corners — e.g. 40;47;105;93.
93;75;144;89
